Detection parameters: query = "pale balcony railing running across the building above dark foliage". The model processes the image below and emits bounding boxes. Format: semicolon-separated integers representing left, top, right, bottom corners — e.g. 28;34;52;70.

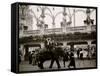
23;25;96;36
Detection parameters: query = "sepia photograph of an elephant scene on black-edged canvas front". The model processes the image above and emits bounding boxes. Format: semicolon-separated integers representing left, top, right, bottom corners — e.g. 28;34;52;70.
18;4;97;72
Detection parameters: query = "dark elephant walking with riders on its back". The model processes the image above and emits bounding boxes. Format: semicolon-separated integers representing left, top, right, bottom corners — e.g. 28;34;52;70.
36;47;68;69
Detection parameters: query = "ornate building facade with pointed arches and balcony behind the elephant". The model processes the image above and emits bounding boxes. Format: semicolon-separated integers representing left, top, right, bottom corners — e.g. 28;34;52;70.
19;6;96;60
